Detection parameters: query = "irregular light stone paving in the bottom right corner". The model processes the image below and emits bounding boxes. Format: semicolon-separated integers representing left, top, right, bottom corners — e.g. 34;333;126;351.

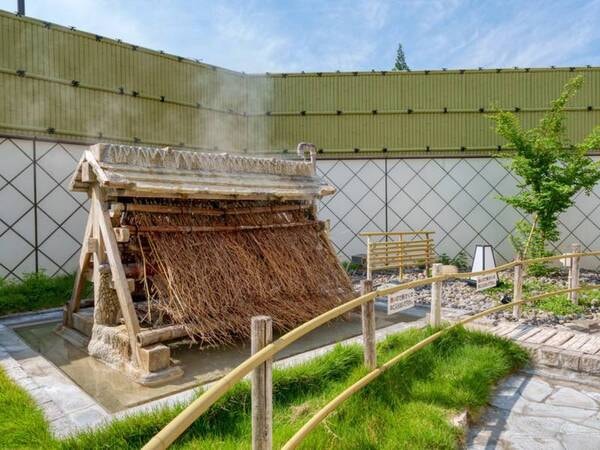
467;369;600;450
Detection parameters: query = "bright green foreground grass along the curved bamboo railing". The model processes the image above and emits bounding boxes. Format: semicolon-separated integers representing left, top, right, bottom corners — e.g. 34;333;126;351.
0;328;527;449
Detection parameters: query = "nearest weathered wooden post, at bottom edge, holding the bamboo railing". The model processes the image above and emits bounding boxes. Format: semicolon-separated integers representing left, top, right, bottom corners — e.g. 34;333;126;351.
251;316;273;450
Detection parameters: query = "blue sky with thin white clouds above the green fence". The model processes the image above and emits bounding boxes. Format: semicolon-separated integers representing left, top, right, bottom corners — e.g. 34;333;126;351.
0;0;600;72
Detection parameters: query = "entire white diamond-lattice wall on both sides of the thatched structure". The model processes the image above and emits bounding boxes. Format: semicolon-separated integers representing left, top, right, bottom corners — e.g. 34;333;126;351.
0;137;600;278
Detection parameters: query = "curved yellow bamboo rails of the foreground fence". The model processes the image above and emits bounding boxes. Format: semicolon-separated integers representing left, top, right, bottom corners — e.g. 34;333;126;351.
144;251;600;450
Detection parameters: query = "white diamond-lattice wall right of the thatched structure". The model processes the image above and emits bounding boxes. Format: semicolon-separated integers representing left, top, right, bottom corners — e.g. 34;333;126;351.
318;158;600;267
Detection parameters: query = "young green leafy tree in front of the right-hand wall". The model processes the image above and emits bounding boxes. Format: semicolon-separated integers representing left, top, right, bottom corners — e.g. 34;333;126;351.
490;76;600;266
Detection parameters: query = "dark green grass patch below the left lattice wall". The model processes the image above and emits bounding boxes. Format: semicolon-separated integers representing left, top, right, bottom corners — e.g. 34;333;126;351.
0;272;91;316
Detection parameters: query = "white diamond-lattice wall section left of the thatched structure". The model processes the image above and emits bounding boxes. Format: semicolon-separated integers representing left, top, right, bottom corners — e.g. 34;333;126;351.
0;138;87;278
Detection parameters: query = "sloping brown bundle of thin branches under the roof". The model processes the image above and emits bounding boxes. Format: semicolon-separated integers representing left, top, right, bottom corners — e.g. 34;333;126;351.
125;200;352;346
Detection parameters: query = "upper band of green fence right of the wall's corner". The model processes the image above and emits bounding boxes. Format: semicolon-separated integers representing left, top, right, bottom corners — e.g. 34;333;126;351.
268;69;600;112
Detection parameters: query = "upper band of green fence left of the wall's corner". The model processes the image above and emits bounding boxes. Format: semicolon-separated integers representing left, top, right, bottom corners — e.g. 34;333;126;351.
0;13;243;110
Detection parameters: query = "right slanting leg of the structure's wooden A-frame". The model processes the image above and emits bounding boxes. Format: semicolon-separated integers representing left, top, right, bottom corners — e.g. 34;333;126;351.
92;184;140;365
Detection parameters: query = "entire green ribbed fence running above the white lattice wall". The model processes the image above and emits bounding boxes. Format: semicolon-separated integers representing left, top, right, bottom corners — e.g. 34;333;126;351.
0;12;600;156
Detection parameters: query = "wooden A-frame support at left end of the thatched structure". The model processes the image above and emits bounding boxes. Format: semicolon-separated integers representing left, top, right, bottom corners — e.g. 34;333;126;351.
64;183;140;366
